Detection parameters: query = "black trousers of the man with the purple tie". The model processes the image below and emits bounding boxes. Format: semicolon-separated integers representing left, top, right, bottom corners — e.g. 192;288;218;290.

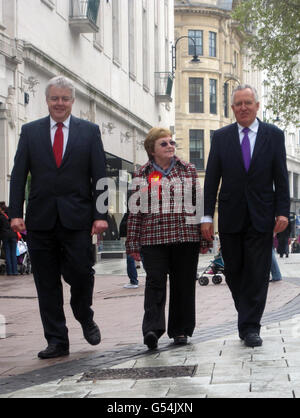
220;217;273;338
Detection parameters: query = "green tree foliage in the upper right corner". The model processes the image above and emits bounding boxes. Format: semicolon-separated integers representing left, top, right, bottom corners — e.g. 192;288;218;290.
233;0;300;126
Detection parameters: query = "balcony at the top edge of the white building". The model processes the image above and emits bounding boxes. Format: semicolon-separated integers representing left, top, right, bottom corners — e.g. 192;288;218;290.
70;0;100;33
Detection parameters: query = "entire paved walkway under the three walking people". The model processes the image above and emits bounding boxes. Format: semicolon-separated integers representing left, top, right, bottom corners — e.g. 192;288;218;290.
0;254;300;398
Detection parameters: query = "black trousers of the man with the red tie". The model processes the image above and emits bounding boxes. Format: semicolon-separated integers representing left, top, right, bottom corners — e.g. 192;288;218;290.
27;221;94;344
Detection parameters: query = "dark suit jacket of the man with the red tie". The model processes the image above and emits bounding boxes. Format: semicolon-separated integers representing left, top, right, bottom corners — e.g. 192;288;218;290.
9;116;106;231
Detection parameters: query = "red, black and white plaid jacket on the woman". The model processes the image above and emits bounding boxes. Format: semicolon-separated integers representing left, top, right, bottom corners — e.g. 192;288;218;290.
126;157;211;254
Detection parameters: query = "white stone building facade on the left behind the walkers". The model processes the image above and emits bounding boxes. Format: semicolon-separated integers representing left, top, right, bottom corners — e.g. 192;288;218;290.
0;0;175;217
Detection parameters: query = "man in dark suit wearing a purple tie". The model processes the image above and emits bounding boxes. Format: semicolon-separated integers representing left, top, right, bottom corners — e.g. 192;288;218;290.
201;85;290;347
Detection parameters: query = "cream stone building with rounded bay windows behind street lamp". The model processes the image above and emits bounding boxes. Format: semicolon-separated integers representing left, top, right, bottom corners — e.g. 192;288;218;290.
175;0;243;188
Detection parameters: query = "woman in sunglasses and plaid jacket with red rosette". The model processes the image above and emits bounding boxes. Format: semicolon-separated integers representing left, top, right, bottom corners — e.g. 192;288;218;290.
126;128;210;349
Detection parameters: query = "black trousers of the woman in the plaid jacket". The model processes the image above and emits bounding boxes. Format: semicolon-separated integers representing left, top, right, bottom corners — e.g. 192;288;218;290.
142;242;200;338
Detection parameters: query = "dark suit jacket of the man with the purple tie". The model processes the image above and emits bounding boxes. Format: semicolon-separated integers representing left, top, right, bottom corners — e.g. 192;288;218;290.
204;121;290;233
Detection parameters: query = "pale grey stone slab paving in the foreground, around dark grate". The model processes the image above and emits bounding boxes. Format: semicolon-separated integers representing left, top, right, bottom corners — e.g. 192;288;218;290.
0;315;300;399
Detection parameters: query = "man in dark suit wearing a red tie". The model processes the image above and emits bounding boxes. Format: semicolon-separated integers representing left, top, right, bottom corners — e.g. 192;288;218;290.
10;76;107;359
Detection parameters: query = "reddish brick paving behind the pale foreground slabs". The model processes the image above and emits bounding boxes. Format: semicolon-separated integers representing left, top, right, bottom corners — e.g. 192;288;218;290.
0;254;300;393
